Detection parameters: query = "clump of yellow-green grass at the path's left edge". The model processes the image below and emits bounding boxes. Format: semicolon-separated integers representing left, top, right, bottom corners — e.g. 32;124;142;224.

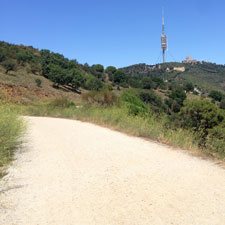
0;105;25;177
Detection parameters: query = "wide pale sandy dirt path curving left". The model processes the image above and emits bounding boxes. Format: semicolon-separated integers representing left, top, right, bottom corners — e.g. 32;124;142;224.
0;118;225;225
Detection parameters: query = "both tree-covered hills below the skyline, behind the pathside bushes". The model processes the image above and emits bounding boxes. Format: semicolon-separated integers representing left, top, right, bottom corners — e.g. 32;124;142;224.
0;41;225;101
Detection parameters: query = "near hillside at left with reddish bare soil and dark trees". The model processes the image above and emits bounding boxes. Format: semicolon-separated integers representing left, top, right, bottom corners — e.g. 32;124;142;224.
0;42;108;103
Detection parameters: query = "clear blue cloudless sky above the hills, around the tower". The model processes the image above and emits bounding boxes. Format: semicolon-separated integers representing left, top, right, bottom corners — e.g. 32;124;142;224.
0;0;225;67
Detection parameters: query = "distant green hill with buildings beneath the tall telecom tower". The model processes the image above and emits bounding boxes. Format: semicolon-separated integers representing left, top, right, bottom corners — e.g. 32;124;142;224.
121;62;225;93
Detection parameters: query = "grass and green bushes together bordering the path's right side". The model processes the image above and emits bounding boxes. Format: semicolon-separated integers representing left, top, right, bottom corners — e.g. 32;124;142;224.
16;89;225;159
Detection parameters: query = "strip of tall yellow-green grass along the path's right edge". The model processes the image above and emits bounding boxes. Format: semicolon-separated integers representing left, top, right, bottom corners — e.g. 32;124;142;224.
16;103;198;154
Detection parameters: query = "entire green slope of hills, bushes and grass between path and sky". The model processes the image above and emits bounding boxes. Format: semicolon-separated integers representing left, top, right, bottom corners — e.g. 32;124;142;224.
0;42;225;165
